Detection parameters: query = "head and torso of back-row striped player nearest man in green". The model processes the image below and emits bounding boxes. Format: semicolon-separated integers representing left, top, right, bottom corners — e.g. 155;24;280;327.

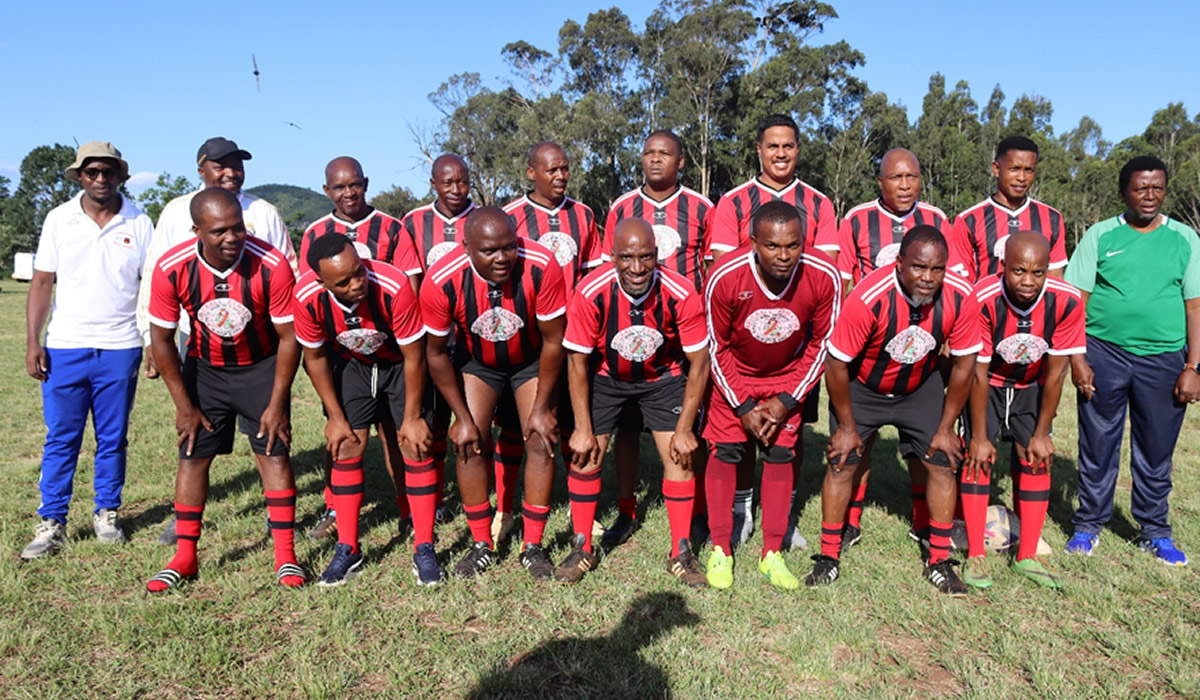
948;136;1067;283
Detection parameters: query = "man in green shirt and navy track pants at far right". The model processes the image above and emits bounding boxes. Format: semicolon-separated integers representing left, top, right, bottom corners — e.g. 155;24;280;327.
1066;156;1200;566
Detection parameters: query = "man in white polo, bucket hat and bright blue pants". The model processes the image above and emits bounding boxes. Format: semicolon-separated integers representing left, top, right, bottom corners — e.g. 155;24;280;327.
20;142;152;561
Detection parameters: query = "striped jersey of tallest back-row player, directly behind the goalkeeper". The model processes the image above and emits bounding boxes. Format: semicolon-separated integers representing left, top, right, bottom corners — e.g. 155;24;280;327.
708;178;838;255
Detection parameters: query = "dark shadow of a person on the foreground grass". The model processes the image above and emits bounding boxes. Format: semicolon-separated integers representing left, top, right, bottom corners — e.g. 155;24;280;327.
468;592;701;698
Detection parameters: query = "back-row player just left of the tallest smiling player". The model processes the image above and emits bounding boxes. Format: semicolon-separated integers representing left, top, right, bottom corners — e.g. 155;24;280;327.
604;131;714;548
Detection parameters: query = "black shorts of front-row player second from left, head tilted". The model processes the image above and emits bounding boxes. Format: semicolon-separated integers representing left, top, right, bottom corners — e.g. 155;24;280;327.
334;359;433;430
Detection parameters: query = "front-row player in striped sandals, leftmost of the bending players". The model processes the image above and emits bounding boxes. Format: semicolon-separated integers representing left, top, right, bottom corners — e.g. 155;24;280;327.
146;187;305;593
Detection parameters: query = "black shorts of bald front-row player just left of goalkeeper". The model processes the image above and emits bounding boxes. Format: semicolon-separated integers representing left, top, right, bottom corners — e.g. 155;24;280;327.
592;375;688;435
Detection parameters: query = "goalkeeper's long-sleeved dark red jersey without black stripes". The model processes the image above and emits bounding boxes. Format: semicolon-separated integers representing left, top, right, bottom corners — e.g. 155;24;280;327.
704;246;841;408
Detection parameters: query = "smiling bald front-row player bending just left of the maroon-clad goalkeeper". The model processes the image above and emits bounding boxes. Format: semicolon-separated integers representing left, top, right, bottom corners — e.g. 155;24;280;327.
554;219;709;588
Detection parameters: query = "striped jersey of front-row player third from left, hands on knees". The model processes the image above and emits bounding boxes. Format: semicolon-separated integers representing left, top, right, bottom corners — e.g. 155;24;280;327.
421;239;566;370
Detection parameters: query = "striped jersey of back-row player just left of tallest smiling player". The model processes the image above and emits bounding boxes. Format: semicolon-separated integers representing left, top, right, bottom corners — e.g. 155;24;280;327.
604;185;715;291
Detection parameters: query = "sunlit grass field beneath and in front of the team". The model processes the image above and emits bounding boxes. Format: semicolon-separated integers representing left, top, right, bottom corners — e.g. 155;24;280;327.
0;282;1200;698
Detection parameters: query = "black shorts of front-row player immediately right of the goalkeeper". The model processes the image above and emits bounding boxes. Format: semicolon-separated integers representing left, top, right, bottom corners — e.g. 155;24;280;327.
829;372;950;467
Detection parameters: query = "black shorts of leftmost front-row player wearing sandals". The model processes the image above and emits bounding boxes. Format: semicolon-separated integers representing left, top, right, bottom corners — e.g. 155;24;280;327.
179;355;288;460
